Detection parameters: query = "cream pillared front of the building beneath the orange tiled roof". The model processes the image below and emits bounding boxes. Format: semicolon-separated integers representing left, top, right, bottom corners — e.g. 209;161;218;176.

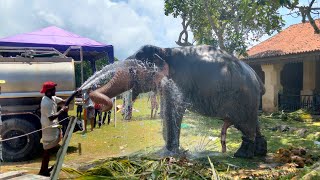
249;52;320;112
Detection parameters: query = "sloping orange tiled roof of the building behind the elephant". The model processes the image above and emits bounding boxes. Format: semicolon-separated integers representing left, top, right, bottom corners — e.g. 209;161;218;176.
245;19;320;59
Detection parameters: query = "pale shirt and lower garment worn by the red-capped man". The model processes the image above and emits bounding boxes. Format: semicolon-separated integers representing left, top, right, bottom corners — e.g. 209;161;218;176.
41;96;62;149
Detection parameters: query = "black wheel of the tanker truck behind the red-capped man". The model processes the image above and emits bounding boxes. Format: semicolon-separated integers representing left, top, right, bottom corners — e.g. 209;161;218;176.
1;118;40;162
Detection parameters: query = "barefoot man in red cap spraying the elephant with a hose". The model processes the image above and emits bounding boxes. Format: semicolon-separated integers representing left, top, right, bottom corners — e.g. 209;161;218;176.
39;81;68;176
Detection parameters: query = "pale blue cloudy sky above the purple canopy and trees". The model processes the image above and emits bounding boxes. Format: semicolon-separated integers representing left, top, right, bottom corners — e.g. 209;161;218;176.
0;0;318;60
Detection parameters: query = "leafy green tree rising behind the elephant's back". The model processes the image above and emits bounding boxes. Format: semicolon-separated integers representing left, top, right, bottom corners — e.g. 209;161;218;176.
165;0;284;55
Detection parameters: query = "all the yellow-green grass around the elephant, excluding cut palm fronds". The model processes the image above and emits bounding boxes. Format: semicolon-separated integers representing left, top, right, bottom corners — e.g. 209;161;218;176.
2;96;320;179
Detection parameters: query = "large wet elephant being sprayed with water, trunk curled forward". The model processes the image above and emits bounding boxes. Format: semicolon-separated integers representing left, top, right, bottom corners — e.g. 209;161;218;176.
82;45;267;158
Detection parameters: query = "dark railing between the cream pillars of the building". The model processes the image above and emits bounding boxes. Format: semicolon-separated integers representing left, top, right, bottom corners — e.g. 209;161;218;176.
278;94;320;114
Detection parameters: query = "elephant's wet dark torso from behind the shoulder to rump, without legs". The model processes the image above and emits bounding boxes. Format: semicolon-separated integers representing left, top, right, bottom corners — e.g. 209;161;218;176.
169;46;259;115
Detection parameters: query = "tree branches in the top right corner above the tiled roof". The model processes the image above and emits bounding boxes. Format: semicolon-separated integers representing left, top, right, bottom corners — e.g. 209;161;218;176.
280;0;320;34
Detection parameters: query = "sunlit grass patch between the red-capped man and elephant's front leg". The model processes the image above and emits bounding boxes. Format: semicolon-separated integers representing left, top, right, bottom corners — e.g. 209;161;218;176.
66;95;164;161
